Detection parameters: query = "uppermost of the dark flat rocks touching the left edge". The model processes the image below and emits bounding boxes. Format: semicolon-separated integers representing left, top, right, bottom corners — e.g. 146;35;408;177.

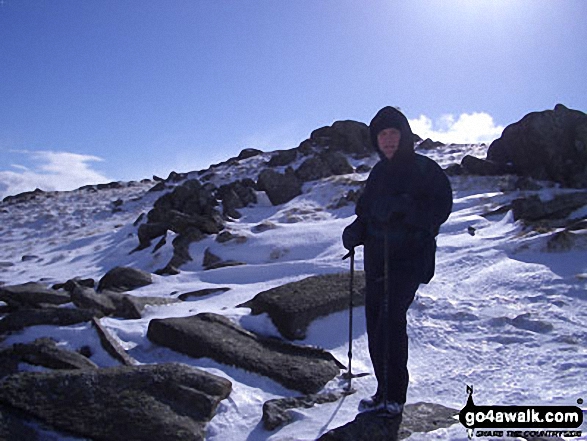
0;282;71;308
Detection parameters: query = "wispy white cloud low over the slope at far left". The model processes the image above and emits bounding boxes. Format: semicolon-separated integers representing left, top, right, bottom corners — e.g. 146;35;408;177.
0;150;109;199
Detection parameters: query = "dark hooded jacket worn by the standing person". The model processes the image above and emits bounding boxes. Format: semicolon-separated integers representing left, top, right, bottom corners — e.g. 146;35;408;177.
343;107;452;283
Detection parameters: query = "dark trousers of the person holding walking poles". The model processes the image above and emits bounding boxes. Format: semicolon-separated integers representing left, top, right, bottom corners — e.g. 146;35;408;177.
365;270;420;404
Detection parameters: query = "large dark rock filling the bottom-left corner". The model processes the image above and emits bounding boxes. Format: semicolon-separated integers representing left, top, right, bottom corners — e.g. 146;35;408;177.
0;363;232;441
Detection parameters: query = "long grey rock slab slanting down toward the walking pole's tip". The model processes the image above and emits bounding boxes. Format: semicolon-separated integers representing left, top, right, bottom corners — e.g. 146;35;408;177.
147;313;344;393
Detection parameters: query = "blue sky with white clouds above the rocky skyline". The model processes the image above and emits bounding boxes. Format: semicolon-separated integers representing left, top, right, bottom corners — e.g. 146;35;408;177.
0;0;587;197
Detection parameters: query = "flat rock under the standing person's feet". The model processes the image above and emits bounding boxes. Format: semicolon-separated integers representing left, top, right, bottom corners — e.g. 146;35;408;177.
318;403;459;441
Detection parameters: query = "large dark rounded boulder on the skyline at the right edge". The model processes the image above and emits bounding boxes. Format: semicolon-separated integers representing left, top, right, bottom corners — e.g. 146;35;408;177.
487;104;587;188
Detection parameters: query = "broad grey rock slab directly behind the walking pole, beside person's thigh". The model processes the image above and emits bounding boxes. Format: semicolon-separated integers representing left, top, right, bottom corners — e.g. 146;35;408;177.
239;272;365;340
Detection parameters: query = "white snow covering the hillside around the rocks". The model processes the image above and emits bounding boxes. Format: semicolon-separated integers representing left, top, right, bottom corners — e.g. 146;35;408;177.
0;145;587;441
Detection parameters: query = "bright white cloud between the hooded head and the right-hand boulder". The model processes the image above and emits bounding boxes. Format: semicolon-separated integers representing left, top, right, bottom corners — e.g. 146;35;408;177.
410;112;504;144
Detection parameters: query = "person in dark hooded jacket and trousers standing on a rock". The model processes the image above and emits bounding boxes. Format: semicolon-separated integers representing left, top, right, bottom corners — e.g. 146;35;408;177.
342;107;452;416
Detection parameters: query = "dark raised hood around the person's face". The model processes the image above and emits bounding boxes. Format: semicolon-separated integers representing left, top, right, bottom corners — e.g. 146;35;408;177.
369;106;414;162
